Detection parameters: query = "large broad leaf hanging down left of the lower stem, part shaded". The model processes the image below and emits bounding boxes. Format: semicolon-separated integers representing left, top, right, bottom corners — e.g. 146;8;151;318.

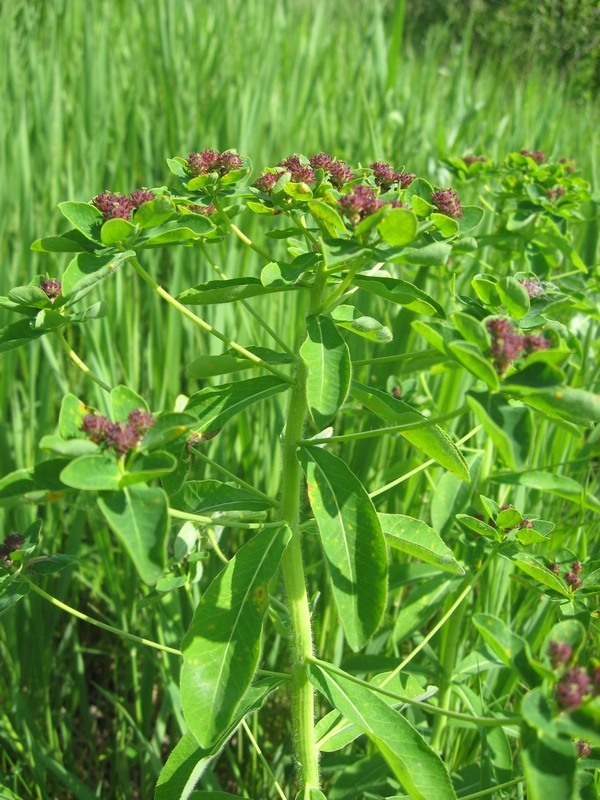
181;527;291;747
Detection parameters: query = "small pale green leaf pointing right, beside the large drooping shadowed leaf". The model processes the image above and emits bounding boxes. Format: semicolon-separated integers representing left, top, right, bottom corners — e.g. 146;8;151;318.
377;514;465;575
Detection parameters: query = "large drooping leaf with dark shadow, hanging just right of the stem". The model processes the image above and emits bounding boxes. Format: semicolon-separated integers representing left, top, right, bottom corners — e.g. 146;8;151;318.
298;447;387;650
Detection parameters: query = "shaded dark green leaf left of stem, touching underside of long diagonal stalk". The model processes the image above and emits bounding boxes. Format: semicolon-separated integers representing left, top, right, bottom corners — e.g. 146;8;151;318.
185;375;290;433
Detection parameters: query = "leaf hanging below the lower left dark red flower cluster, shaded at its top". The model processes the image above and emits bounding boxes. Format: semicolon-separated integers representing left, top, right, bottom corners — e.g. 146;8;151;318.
98;486;169;584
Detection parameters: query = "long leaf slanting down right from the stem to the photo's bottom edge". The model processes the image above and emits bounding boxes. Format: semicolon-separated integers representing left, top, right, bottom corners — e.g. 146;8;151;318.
310;665;456;800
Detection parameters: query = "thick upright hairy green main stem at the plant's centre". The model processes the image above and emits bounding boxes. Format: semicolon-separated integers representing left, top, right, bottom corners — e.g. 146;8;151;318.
281;269;326;789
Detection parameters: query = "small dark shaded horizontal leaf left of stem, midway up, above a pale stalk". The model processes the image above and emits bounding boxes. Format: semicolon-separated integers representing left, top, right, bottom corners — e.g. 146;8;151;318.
171;481;272;514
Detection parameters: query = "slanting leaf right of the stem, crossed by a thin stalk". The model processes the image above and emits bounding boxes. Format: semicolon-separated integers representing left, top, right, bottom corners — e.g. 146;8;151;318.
351;381;471;481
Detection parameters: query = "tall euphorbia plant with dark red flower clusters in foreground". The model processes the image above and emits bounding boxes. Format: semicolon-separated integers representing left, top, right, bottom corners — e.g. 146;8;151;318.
0;150;600;800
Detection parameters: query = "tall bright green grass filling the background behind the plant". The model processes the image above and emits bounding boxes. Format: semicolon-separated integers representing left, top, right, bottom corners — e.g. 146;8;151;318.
0;0;600;800
